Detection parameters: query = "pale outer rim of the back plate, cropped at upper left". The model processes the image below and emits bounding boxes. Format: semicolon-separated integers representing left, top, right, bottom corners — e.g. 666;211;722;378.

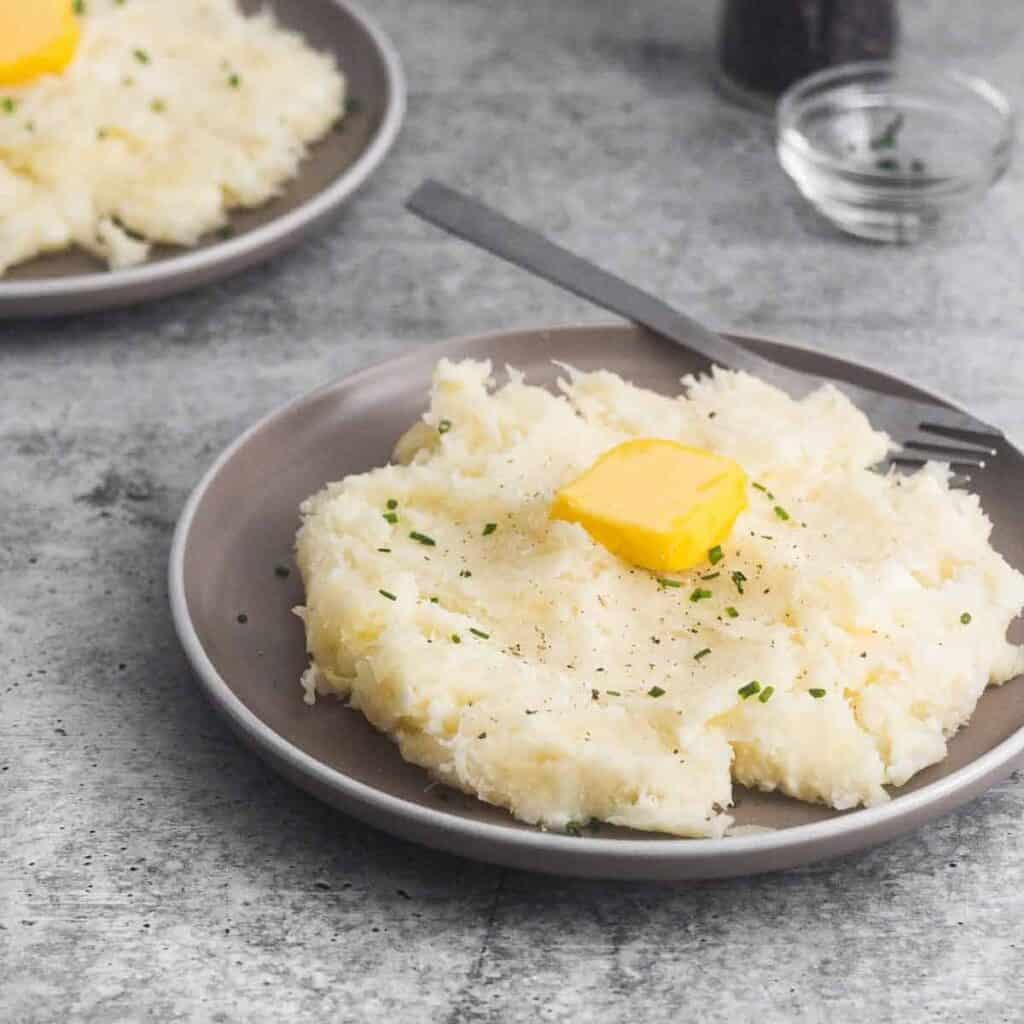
0;0;408;309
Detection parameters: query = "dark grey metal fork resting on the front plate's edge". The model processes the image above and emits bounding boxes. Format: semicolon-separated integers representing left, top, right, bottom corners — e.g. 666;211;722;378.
406;180;1002;471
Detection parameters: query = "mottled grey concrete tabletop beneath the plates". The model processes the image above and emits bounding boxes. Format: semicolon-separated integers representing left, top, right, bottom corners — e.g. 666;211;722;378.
0;0;1024;1024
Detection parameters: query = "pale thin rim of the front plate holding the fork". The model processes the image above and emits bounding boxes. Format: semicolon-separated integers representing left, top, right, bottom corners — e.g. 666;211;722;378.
168;321;1024;879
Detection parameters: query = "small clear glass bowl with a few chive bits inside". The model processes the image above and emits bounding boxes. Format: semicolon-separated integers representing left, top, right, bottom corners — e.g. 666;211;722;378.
776;61;1014;242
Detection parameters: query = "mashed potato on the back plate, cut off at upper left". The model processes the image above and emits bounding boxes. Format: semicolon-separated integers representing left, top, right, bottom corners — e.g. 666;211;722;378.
0;0;345;273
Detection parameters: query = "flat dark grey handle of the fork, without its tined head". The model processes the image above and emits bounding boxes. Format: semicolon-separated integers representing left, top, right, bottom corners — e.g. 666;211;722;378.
406;179;820;397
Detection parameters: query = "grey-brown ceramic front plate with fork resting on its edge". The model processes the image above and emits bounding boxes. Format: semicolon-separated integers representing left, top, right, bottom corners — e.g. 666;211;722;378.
170;327;1024;879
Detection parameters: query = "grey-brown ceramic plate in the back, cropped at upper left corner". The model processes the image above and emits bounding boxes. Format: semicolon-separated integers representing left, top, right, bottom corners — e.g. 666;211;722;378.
0;0;406;318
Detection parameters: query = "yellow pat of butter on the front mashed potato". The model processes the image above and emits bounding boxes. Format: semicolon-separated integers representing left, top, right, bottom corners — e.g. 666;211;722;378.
550;440;746;572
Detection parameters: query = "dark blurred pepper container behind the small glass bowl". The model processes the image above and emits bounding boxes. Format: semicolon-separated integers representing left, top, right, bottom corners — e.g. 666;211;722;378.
719;0;899;109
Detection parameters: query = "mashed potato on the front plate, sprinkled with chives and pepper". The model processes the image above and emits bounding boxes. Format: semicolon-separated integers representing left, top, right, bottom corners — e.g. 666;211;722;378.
298;361;1024;836
